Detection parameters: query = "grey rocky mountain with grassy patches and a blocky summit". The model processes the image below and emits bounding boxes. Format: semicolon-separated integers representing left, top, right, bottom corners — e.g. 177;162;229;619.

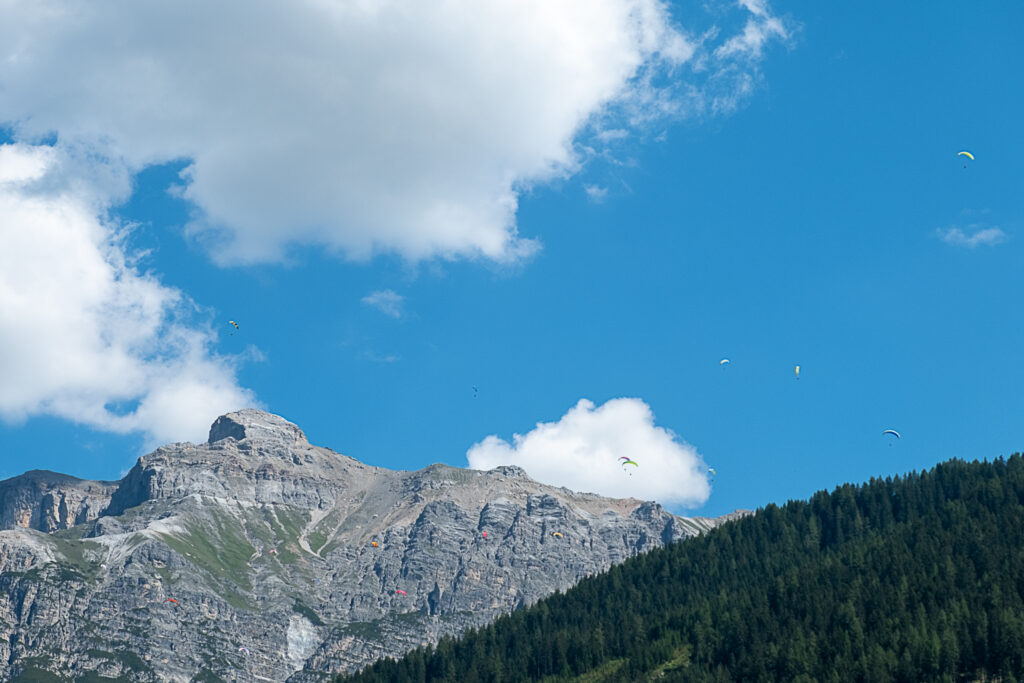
0;410;741;683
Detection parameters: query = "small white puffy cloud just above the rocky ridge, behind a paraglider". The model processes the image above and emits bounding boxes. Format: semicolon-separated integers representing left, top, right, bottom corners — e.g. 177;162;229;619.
466;398;711;507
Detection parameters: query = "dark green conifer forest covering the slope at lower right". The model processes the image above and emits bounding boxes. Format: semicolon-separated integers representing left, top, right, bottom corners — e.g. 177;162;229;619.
338;455;1024;683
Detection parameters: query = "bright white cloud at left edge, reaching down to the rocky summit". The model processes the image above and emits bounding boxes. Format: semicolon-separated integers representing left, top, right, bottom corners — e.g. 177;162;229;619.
0;144;254;444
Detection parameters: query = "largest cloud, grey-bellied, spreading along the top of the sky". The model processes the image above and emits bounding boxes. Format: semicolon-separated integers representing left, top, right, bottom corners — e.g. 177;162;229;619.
0;0;786;263
